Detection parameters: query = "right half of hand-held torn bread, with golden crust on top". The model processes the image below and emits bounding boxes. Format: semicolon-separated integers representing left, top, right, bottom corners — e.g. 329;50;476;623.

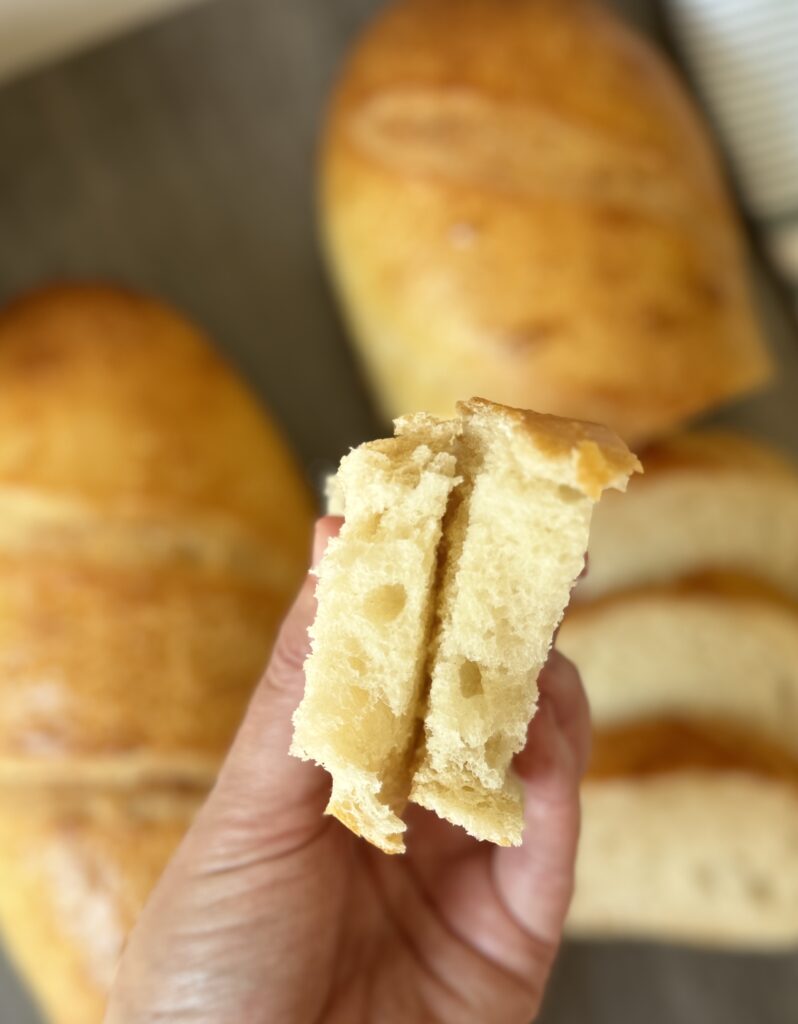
411;399;637;846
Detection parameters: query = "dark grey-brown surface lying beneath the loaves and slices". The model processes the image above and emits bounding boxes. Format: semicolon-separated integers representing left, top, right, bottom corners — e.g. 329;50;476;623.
0;0;798;1024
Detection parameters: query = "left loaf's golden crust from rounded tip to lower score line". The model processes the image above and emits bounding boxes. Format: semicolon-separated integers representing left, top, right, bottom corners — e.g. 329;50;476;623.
0;286;310;783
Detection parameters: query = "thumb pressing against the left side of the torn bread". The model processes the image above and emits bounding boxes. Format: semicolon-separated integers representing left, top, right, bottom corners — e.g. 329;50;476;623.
204;516;341;854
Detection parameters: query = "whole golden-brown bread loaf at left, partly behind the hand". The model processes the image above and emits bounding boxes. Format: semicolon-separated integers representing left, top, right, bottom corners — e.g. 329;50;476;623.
0;286;311;1024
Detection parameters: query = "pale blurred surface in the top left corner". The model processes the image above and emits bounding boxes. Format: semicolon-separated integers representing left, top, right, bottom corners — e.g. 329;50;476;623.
0;0;211;79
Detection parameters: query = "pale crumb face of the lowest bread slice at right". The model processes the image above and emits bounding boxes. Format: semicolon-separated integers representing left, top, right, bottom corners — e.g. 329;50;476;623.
568;771;798;949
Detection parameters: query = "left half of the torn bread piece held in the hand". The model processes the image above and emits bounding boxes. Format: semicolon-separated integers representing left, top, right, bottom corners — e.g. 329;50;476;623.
291;415;459;853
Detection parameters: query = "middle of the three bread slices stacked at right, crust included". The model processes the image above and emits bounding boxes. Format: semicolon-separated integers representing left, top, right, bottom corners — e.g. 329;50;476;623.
558;566;798;752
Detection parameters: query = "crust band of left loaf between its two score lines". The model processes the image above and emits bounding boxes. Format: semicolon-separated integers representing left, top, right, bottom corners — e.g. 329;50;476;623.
0;554;289;783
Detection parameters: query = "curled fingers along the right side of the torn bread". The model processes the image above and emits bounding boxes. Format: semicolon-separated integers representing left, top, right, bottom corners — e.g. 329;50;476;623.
494;655;590;958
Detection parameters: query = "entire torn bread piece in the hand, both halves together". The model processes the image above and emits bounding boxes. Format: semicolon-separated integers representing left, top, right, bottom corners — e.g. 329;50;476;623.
292;399;637;853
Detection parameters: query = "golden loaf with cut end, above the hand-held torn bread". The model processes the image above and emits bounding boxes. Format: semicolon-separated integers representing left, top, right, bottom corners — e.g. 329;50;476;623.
320;0;769;442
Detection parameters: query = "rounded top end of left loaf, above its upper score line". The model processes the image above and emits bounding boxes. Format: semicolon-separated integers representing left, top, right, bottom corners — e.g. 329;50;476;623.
0;285;310;554
